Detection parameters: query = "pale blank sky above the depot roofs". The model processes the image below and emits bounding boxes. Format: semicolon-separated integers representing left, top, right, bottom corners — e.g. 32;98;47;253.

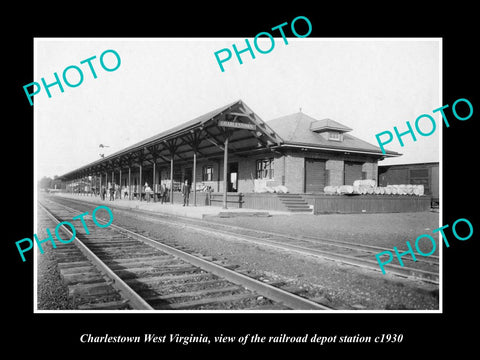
32;37;438;179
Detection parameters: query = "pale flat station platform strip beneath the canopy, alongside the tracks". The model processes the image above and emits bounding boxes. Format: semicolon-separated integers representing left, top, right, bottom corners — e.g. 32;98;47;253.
53;193;292;219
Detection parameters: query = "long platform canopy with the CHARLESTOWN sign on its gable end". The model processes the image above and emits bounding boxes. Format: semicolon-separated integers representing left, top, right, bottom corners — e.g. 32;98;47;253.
61;100;283;181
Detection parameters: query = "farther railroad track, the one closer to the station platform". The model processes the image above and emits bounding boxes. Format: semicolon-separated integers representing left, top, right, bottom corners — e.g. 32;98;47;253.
51;194;439;284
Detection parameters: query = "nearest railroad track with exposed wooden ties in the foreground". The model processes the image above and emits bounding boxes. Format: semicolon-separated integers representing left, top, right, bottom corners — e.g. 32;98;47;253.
38;200;331;310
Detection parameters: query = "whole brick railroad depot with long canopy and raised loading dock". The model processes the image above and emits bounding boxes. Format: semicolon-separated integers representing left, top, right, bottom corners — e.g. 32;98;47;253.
61;100;430;214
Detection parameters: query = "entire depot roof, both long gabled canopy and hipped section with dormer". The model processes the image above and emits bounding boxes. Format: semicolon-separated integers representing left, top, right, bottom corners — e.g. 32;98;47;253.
61;100;400;180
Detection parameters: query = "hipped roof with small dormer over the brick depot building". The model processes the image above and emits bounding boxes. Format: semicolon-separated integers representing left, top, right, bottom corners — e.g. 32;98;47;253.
267;112;401;156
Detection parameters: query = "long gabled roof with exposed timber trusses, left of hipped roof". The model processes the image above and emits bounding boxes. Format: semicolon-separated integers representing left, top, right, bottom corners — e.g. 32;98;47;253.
61;100;282;179
